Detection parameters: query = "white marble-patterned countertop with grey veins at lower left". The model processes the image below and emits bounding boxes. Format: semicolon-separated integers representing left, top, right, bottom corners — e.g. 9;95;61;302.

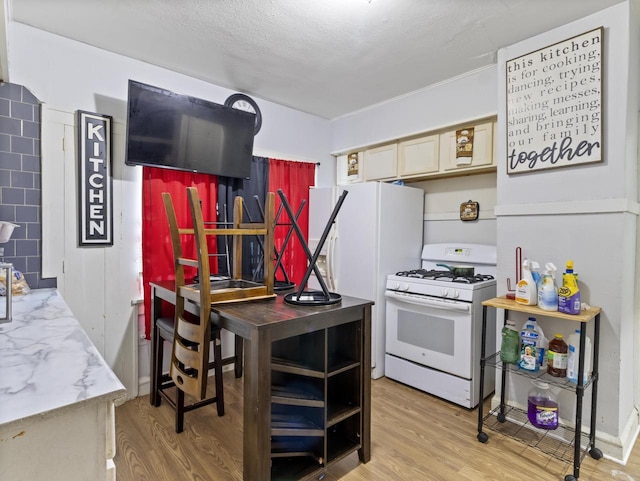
0;289;126;426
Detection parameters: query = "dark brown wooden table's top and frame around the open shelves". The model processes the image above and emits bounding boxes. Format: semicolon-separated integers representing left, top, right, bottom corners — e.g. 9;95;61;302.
151;282;373;481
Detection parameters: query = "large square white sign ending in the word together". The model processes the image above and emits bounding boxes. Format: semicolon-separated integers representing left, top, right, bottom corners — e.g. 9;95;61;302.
506;27;603;174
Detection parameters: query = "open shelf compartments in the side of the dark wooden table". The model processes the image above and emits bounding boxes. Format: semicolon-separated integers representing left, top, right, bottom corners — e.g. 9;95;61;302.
271;321;368;479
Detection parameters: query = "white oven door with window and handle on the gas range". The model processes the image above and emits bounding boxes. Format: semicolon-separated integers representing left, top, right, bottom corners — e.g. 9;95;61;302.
385;291;473;379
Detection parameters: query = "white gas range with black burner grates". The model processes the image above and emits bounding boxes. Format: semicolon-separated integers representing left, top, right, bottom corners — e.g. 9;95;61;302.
385;243;496;408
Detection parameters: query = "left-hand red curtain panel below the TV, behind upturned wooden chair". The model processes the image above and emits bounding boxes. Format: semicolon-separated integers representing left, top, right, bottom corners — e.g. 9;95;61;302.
142;167;217;339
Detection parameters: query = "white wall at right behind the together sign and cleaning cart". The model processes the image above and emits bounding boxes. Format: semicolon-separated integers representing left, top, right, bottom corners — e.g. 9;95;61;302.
496;2;640;459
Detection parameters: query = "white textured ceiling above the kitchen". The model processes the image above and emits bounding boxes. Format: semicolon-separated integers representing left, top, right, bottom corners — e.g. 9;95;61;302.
7;0;622;119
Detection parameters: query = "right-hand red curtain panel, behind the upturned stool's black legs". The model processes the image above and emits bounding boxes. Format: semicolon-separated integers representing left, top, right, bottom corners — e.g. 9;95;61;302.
268;159;316;286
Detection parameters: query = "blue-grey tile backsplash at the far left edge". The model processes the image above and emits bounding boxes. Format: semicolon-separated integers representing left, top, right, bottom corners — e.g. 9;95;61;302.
0;83;56;289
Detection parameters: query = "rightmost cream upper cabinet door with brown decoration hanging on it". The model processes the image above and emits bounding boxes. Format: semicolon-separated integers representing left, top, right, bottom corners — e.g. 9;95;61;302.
440;121;495;171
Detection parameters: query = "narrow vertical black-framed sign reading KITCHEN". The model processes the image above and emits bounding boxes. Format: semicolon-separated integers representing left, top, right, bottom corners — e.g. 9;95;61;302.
76;110;113;246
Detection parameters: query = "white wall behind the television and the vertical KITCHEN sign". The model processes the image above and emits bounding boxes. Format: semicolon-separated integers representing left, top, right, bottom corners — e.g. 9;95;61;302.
6;23;335;396
